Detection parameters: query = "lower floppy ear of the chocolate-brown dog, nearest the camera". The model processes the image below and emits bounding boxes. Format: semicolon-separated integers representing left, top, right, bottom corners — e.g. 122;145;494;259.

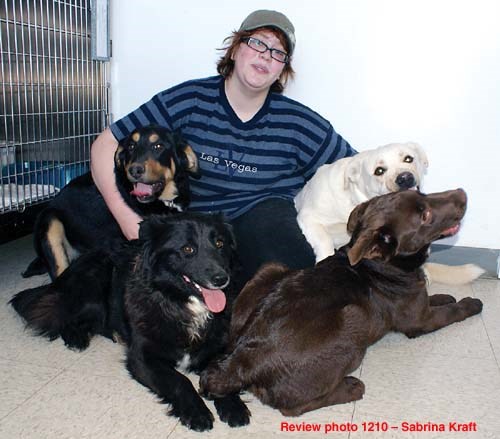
347;227;397;265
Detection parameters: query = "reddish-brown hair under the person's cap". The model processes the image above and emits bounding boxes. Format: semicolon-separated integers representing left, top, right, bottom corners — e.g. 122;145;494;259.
217;27;295;93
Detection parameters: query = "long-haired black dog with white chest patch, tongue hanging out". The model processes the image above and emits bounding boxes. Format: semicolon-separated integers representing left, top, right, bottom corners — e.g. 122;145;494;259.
10;213;249;431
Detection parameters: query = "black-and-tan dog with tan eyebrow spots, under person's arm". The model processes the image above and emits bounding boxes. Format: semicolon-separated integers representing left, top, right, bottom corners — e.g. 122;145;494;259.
23;125;198;279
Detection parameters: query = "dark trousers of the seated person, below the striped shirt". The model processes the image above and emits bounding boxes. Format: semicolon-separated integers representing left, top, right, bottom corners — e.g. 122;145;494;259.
232;198;315;288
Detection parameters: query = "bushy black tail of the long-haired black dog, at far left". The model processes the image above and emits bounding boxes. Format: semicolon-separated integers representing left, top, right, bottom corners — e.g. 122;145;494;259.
9;284;62;340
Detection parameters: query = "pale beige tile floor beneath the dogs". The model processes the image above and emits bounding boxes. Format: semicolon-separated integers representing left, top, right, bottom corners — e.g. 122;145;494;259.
0;237;500;439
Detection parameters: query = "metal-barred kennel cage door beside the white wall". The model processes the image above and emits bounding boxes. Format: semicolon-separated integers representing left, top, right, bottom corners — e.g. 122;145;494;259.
0;0;109;213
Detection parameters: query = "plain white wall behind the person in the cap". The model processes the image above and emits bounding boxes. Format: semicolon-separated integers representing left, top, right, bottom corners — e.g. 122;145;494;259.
111;0;500;248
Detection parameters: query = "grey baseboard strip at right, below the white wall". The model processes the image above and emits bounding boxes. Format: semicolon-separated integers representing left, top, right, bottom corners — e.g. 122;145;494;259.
429;244;500;278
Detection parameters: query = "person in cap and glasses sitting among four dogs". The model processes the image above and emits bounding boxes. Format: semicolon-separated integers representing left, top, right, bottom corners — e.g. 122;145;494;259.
91;10;356;286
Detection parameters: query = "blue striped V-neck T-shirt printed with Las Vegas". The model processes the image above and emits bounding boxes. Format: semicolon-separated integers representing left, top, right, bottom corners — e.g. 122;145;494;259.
111;76;356;219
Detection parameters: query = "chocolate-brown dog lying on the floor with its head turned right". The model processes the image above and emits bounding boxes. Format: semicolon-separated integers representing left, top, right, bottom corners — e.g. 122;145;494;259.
200;189;482;416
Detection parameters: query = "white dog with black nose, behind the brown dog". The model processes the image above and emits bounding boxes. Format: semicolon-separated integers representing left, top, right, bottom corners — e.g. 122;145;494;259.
295;142;484;284
